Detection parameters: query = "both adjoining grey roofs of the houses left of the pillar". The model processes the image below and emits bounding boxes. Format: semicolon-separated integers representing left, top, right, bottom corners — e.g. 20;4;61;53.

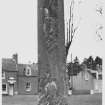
2;58;38;76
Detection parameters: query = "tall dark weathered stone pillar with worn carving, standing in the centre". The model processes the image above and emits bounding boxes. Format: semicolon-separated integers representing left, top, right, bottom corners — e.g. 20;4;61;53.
38;0;66;105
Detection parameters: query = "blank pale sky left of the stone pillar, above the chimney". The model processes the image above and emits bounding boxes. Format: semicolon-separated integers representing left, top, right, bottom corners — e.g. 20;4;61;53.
0;0;37;63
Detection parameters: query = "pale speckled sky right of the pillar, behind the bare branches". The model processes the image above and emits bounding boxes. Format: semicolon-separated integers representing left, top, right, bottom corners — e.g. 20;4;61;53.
65;0;105;62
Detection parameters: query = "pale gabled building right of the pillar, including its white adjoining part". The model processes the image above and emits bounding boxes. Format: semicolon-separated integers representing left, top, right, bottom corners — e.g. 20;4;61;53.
70;65;102;94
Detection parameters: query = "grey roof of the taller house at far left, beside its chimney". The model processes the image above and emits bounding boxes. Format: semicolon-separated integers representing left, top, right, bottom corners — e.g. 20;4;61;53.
2;58;17;71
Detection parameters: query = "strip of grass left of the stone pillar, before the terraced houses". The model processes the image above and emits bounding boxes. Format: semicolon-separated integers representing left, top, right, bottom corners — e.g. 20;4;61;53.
2;95;38;105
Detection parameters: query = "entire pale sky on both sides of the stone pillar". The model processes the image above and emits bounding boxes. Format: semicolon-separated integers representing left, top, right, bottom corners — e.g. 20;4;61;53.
0;0;105;63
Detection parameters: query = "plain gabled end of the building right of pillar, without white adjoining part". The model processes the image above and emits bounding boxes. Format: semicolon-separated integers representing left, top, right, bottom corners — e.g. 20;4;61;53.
72;70;94;94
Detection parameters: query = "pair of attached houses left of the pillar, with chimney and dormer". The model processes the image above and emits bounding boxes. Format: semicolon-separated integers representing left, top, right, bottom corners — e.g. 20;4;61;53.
2;54;38;96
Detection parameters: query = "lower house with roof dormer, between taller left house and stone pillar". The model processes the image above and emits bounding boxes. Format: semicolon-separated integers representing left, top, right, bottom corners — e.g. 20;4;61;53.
18;64;38;95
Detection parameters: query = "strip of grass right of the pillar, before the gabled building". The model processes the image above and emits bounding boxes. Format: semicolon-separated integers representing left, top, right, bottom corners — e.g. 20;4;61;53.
68;94;102;105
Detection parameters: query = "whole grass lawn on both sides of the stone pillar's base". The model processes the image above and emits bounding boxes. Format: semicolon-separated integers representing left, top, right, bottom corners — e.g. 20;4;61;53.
2;94;102;105
